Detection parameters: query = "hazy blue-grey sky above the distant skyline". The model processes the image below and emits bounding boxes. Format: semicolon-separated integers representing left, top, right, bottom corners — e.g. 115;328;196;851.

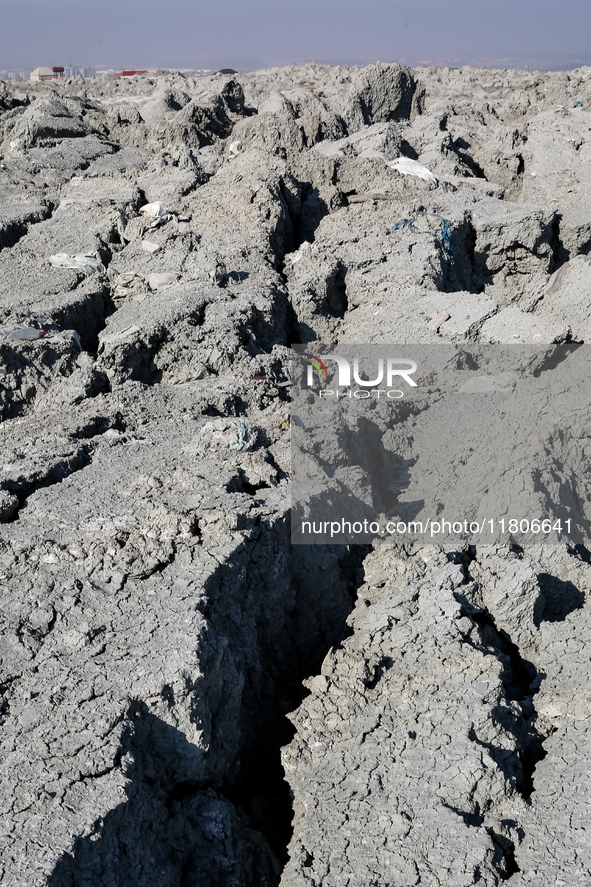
0;0;591;70
